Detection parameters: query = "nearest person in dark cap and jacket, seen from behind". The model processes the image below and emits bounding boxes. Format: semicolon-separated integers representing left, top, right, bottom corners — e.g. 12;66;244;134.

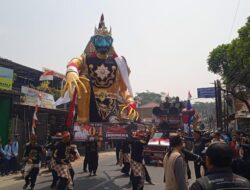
190;142;250;190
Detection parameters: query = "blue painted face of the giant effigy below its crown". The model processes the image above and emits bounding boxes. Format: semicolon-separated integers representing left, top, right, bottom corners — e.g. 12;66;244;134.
91;35;113;54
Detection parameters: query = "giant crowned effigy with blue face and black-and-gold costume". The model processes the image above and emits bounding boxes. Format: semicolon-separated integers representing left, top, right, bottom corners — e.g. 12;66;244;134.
63;15;138;123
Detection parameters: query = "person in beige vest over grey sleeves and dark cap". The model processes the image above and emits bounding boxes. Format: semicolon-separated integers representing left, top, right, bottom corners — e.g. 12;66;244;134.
163;134;188;190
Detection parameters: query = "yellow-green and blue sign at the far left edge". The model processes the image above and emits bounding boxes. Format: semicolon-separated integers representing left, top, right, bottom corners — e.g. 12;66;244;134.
0;67;13;90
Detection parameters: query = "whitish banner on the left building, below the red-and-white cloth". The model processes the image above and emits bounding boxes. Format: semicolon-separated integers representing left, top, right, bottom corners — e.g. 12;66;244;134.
20;86;55;109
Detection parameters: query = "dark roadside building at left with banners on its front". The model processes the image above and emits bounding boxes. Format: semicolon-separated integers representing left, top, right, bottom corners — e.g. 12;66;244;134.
0;58;67;151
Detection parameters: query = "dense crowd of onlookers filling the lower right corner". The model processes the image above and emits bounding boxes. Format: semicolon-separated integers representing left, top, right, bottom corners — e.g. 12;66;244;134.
163;130;250;190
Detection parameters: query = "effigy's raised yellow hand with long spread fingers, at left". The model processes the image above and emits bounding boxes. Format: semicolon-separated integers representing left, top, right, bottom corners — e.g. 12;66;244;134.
62;72;88;98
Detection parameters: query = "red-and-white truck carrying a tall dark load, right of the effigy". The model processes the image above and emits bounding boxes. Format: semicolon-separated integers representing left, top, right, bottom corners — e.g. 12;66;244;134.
143;97;184;164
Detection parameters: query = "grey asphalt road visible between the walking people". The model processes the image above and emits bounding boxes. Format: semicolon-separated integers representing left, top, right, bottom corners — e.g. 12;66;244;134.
0;152;194;190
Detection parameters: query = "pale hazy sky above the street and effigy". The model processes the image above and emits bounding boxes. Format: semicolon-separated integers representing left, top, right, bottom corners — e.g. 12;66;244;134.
0;0;250;99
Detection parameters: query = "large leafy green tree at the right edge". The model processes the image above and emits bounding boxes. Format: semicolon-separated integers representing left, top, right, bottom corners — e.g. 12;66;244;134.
207;17;250;111
